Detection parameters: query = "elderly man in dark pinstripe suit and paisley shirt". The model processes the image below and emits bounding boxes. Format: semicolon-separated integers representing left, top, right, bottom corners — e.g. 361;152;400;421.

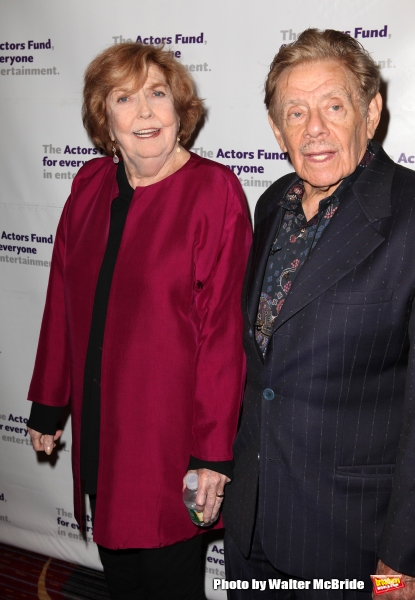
224;29;415;600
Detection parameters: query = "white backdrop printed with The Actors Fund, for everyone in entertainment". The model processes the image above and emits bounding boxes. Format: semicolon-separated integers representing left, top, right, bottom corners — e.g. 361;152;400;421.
0;0;415;599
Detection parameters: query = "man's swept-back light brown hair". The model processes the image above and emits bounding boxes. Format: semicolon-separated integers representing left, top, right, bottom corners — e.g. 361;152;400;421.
264;29;380;124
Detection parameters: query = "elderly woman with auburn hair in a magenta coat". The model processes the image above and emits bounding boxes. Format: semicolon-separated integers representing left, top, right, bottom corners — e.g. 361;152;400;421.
29;44;254;600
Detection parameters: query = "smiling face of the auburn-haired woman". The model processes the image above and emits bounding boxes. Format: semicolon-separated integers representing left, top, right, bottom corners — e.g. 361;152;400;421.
107;65;179;168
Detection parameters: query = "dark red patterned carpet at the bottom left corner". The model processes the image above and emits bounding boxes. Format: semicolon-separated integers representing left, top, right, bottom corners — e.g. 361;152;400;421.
0;543;109;600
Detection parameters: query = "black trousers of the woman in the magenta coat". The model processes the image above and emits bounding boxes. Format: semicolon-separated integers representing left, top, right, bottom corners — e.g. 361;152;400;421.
90;496;206;600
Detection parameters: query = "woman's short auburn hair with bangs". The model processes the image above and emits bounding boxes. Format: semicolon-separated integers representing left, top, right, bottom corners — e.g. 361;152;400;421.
82;42;205;154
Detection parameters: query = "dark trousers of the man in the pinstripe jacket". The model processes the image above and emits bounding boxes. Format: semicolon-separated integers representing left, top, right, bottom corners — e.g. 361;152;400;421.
225;528;372;600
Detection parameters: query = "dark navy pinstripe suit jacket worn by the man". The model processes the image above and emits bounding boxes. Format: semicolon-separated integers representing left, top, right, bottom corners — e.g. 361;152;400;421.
224;144;415;579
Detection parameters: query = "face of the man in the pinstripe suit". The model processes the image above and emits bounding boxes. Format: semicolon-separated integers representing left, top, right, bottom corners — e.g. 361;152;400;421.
270;60;382;193
